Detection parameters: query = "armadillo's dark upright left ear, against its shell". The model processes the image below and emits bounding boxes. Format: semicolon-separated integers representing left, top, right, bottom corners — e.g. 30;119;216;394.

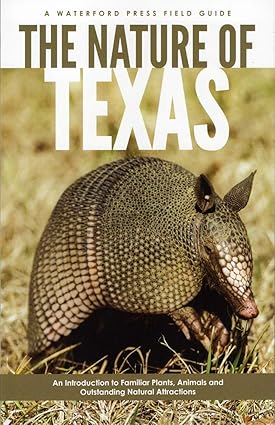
195;174;215;213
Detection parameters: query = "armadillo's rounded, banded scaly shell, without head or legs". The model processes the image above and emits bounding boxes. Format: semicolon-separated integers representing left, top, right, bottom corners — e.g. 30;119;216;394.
28;158;202;354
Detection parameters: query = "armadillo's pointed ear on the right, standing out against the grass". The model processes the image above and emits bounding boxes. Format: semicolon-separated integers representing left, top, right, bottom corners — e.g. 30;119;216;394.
223;170;256;212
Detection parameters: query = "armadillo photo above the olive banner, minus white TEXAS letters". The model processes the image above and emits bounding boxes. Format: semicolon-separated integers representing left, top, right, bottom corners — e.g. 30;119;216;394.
1;69;275;373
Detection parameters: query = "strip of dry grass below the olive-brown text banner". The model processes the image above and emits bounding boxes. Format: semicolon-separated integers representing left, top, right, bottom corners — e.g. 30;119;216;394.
1;400;275;425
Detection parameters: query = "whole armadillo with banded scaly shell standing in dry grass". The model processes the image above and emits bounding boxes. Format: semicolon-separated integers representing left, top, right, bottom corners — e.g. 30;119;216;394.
28;157;258;355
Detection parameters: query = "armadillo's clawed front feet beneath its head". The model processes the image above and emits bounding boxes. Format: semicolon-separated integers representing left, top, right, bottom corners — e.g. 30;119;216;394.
169;306;229;353
